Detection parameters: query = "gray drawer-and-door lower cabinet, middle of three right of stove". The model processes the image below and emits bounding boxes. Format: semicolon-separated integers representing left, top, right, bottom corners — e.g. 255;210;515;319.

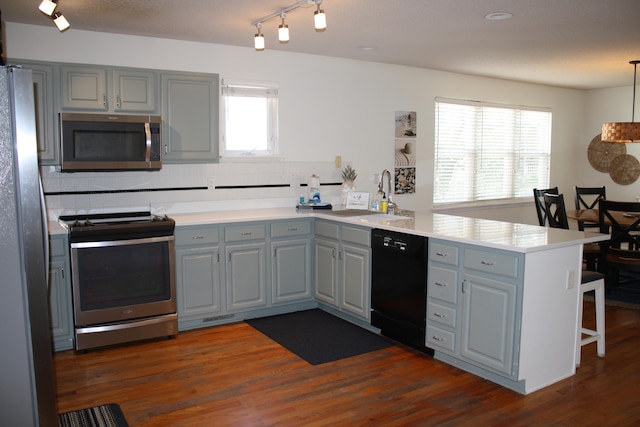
224;223;268;312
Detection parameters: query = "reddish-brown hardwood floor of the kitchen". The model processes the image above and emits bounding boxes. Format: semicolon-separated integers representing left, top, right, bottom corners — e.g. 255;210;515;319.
55;303;640;427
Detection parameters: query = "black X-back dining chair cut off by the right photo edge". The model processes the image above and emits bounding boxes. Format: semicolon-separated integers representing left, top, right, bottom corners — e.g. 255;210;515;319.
598;200;640;287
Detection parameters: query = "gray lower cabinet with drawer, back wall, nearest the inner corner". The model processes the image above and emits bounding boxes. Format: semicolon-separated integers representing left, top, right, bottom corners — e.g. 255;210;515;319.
270;219;312;305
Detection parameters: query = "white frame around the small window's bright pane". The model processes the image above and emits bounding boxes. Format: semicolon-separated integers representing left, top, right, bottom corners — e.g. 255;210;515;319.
220;79;279;159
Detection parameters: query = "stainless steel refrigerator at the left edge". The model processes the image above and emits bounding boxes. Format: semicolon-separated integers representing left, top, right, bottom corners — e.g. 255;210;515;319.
0;67;58;426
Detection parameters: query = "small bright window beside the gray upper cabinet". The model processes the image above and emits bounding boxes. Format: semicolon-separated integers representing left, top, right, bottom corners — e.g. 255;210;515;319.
220;82;278;157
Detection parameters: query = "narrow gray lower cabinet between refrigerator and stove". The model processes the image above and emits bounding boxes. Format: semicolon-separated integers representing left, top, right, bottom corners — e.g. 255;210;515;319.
49;234;74;351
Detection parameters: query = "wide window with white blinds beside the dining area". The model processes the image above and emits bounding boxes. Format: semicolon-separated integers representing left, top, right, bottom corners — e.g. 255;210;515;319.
433;99;551;206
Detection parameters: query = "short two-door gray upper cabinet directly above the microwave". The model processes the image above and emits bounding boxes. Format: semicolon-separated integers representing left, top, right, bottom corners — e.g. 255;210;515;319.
60;64;158;114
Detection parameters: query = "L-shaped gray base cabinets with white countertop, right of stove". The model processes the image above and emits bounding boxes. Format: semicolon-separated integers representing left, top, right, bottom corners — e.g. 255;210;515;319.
50;208;605;394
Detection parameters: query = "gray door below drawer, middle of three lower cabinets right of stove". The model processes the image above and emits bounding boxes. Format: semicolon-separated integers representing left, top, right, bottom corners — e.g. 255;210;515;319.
225;242;267;310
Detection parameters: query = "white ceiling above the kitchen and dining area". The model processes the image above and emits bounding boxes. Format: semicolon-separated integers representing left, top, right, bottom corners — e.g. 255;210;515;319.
0;0;640;89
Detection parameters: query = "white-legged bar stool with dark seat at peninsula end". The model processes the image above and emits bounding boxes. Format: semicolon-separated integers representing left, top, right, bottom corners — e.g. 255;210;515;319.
576;270;605;367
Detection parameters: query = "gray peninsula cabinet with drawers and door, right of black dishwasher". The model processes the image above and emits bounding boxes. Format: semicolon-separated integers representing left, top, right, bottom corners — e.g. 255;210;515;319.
426;239;524;380
